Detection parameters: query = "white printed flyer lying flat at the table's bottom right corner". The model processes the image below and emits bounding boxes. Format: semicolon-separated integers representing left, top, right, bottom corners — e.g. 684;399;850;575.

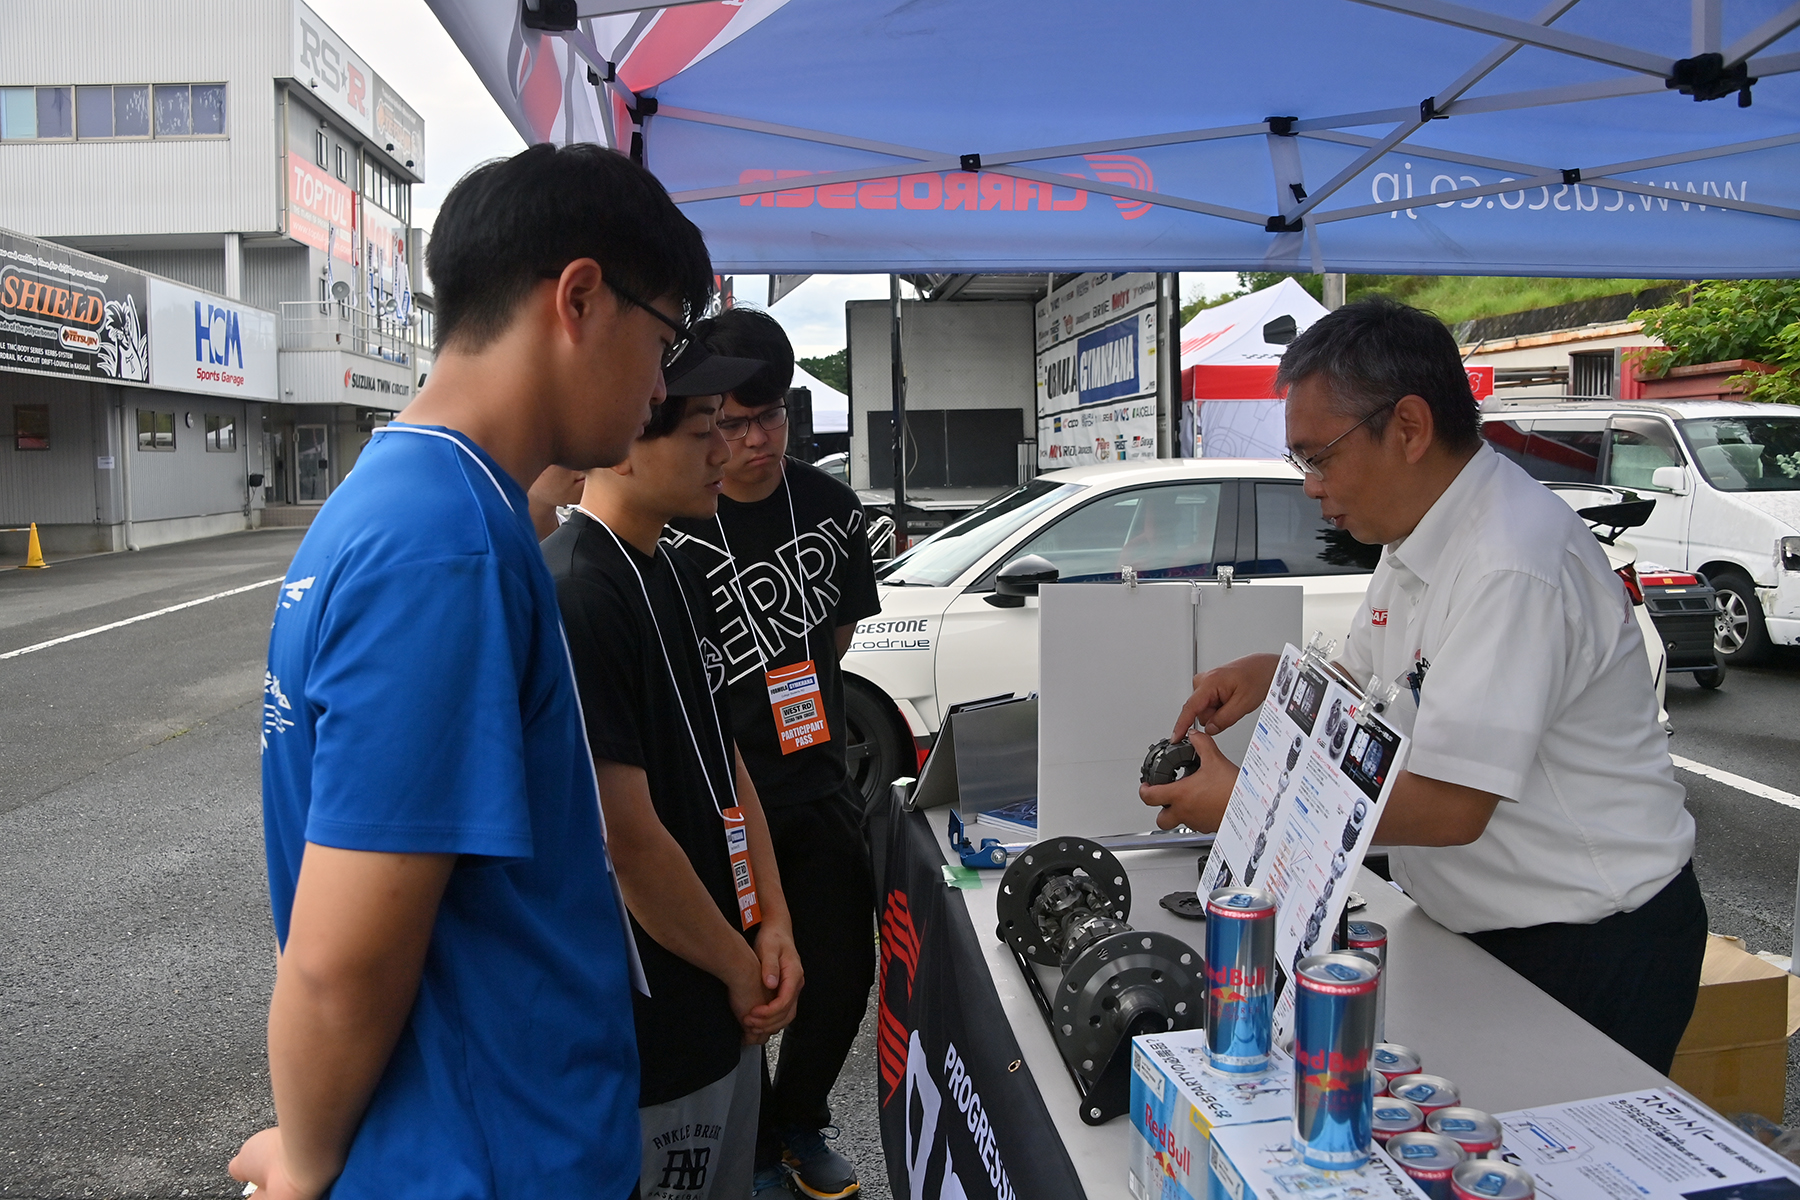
1499;1088;1800;1200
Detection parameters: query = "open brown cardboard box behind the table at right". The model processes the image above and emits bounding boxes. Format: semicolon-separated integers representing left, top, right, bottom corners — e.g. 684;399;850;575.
1669;934;1800;1124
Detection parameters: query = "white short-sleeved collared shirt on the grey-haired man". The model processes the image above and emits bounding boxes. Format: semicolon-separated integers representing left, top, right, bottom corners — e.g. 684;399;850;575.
1341;444;1694;934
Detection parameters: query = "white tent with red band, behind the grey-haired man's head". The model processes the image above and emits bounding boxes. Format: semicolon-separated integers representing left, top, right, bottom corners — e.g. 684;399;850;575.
1181;279;1325;459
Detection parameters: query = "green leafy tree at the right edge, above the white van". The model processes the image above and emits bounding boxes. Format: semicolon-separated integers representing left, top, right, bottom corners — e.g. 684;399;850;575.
1633;279;1800;405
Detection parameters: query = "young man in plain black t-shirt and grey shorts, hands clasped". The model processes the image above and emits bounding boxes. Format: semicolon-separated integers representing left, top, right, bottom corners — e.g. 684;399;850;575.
544;360;801;1200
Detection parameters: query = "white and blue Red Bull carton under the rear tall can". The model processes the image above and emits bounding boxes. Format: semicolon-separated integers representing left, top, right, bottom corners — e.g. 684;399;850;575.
1127;1029;1294;1200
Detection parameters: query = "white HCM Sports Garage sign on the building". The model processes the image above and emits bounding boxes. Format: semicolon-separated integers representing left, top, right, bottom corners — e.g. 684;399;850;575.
149;279;281;399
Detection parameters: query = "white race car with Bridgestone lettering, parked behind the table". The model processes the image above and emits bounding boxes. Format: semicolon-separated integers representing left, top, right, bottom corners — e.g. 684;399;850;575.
844;459;1667;801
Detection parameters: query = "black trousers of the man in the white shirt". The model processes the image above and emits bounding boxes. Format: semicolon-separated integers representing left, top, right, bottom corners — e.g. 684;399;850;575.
1469;862;1706;1074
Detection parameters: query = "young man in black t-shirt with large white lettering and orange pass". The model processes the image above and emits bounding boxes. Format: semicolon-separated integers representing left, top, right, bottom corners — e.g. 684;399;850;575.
671;308;880;1200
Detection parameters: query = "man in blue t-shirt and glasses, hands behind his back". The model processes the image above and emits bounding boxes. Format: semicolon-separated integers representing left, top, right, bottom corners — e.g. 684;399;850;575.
232;146;711;1200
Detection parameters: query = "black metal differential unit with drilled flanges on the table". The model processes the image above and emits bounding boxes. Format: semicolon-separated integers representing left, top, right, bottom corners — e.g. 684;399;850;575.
995;837;1206;1124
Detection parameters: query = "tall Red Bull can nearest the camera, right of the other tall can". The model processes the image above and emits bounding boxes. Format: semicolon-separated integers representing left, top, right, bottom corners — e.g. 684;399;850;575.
1294;954;1381;1171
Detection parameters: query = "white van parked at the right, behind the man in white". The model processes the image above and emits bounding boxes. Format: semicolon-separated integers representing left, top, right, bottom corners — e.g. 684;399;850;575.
1483;399;1800;666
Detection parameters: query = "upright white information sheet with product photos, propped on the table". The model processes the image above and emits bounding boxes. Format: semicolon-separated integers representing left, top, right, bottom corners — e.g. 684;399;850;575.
1199;646;1408;1042
